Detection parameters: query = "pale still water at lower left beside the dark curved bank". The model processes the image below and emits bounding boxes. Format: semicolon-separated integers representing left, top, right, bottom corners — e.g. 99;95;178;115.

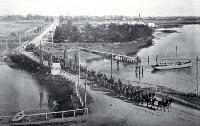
0;64;47;115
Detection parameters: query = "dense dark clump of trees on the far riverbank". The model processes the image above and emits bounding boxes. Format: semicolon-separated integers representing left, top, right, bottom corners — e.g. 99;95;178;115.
54;21;153;43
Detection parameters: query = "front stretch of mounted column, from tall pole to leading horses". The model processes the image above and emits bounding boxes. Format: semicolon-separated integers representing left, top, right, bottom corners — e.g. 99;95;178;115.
81;66;174;111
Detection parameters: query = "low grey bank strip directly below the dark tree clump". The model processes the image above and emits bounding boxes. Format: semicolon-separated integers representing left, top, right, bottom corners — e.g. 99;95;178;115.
44;36;154;59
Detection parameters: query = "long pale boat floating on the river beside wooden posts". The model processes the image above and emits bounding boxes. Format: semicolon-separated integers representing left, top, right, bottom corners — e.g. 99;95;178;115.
152;61;192;70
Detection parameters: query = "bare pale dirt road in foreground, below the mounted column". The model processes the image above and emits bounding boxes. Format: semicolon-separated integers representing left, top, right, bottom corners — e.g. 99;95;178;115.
74;79;200;126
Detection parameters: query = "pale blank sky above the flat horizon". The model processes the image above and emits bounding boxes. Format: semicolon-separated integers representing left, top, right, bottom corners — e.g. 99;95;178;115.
0;0;200;16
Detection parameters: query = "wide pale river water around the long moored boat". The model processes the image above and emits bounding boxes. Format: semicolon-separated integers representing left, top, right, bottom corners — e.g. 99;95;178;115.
83;25;200;92
